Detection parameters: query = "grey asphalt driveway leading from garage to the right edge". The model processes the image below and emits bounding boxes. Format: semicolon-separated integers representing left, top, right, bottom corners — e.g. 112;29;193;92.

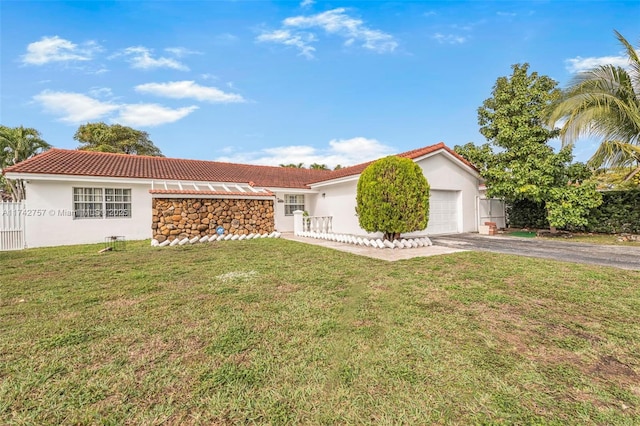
431;234;640;270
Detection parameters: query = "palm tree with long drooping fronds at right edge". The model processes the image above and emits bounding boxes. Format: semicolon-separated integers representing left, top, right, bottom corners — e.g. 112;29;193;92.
548;31;640;181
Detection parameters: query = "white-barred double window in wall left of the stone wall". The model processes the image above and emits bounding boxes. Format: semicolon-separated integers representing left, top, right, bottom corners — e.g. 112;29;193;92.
73;188;131;219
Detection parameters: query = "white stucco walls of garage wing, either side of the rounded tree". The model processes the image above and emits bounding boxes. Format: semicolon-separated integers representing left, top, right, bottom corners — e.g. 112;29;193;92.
309;154;479;235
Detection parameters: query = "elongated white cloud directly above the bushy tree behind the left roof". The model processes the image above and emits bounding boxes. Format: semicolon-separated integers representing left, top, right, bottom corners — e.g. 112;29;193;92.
33;88;198;126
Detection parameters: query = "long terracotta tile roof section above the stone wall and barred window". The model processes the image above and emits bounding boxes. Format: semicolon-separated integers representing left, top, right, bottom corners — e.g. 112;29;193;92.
4;148;331;188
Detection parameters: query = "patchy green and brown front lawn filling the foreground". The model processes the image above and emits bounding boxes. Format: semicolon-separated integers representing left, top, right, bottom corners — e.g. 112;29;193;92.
0;240;640;425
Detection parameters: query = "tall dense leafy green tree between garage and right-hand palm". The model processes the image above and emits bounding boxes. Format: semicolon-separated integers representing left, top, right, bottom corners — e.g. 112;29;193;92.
478;64;602;229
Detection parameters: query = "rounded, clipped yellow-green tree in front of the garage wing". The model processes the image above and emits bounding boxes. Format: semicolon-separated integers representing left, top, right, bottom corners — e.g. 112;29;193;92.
356;156;429;241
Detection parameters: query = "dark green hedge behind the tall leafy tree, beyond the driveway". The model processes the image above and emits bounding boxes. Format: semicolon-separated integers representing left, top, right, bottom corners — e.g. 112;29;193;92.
507;189;640;234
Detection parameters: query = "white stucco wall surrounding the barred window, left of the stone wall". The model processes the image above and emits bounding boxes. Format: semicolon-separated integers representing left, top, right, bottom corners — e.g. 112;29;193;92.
25;179;151;247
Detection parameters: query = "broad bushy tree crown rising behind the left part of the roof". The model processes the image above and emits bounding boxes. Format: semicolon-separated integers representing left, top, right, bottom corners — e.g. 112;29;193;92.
73;123;163;157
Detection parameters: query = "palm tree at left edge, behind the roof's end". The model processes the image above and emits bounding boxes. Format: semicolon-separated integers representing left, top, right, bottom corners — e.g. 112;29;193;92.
0;125;51;201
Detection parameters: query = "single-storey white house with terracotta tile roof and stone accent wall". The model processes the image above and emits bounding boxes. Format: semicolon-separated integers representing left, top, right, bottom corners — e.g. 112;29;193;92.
4;143;490;247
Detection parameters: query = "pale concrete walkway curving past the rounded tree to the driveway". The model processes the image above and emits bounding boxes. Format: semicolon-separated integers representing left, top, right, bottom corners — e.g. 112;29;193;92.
280;232;465;262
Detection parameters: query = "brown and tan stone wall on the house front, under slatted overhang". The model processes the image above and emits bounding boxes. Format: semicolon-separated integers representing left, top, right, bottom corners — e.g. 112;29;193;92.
156;198;275;242
